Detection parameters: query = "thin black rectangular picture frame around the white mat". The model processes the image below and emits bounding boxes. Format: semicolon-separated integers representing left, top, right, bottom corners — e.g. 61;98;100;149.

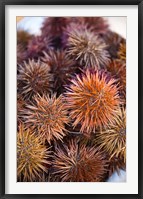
0;0;143;199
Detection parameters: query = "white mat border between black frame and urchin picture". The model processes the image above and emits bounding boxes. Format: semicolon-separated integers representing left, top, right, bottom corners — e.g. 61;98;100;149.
5;5;138;194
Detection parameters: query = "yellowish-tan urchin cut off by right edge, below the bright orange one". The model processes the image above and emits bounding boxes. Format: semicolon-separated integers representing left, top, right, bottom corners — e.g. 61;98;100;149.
96;108;126;162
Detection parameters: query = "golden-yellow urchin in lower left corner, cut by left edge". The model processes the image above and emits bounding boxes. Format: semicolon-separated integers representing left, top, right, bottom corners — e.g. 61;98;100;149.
17;124;50;182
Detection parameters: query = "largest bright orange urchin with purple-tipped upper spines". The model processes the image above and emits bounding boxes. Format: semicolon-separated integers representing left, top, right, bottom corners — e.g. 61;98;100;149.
65;69;120;134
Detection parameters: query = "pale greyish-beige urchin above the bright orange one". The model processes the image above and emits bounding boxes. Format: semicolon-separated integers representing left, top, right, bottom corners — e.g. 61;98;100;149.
67;29;110;69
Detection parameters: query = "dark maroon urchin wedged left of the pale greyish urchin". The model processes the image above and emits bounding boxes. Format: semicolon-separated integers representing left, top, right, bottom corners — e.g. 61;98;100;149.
42;50;77;91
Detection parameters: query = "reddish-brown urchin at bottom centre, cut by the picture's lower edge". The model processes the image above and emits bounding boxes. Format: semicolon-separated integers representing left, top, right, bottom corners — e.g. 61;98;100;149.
53;139;107;182
